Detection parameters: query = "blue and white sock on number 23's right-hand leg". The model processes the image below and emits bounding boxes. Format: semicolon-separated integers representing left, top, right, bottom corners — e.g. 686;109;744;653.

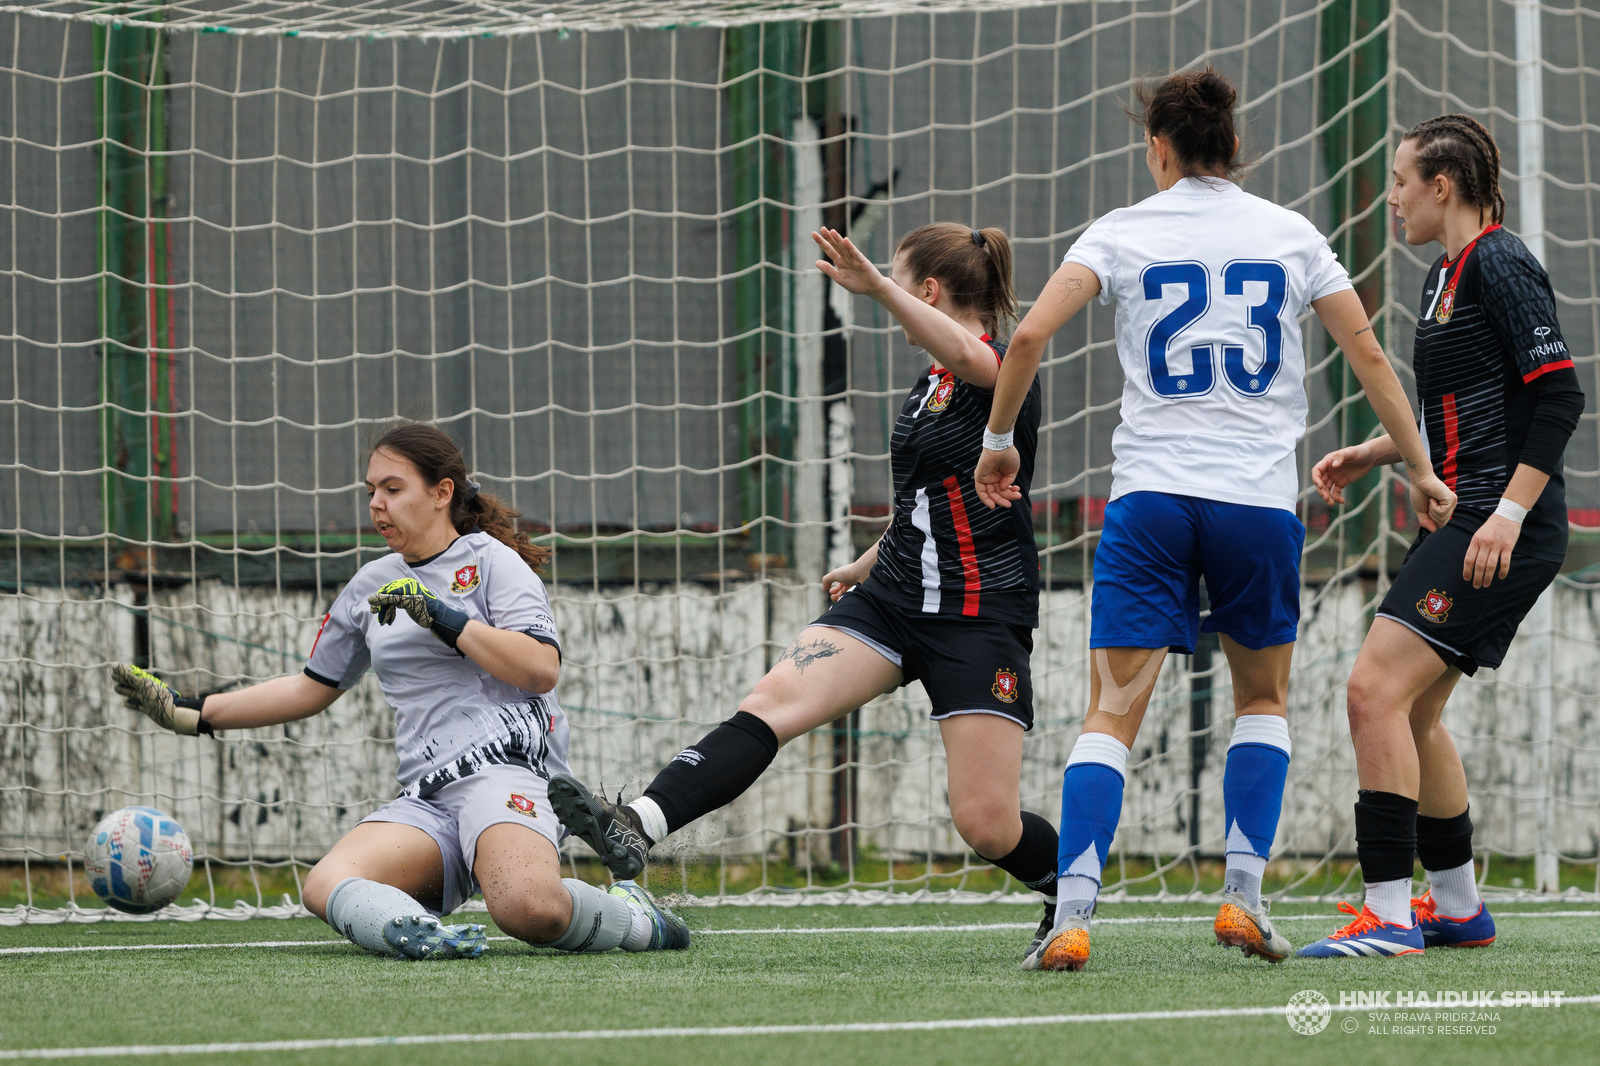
1222;714;1290;908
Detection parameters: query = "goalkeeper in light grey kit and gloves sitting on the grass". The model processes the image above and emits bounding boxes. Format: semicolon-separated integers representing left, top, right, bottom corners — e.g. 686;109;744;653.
114;424;690;959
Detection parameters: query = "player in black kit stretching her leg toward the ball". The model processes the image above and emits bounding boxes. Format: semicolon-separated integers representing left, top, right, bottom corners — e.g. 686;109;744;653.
550;222;1056;960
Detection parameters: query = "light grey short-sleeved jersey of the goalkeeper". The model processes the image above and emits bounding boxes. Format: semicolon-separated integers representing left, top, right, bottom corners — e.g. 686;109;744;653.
306;531;568;797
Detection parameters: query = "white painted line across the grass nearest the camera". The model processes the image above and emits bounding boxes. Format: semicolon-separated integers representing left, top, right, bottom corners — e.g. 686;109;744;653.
0;996;1600;1061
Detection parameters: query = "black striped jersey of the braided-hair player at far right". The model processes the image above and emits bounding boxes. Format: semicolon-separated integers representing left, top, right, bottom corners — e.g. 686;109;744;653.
1414;226;1584;559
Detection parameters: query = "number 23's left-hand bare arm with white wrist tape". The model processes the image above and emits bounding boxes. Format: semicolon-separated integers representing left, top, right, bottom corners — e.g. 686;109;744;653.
976;262;1101;509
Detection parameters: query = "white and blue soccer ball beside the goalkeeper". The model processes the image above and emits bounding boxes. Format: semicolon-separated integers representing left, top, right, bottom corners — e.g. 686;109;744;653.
83;807;194;914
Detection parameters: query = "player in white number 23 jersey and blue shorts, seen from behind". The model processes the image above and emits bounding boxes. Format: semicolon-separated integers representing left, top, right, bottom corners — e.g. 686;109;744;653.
976;69;1454;970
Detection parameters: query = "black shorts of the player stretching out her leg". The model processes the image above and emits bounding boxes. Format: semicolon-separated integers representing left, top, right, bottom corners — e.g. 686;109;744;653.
811;584;1034;730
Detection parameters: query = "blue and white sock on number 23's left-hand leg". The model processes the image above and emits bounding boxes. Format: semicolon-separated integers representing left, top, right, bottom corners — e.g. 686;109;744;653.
1056;733;1128;919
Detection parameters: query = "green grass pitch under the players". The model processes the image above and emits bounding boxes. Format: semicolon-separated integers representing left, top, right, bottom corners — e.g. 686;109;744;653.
0;903;1600;1066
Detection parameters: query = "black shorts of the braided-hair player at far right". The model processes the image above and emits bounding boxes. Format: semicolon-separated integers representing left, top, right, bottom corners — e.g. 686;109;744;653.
1378;514;1562;675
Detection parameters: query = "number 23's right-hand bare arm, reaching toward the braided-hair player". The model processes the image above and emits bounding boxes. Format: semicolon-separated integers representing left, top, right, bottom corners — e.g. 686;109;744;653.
1312;288;1456;527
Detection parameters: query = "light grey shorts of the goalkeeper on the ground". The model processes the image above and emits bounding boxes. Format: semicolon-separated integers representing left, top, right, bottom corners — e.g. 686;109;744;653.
362;763;563;917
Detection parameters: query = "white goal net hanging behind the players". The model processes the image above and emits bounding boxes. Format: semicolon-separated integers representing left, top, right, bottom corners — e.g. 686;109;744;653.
0;0;1600;922
